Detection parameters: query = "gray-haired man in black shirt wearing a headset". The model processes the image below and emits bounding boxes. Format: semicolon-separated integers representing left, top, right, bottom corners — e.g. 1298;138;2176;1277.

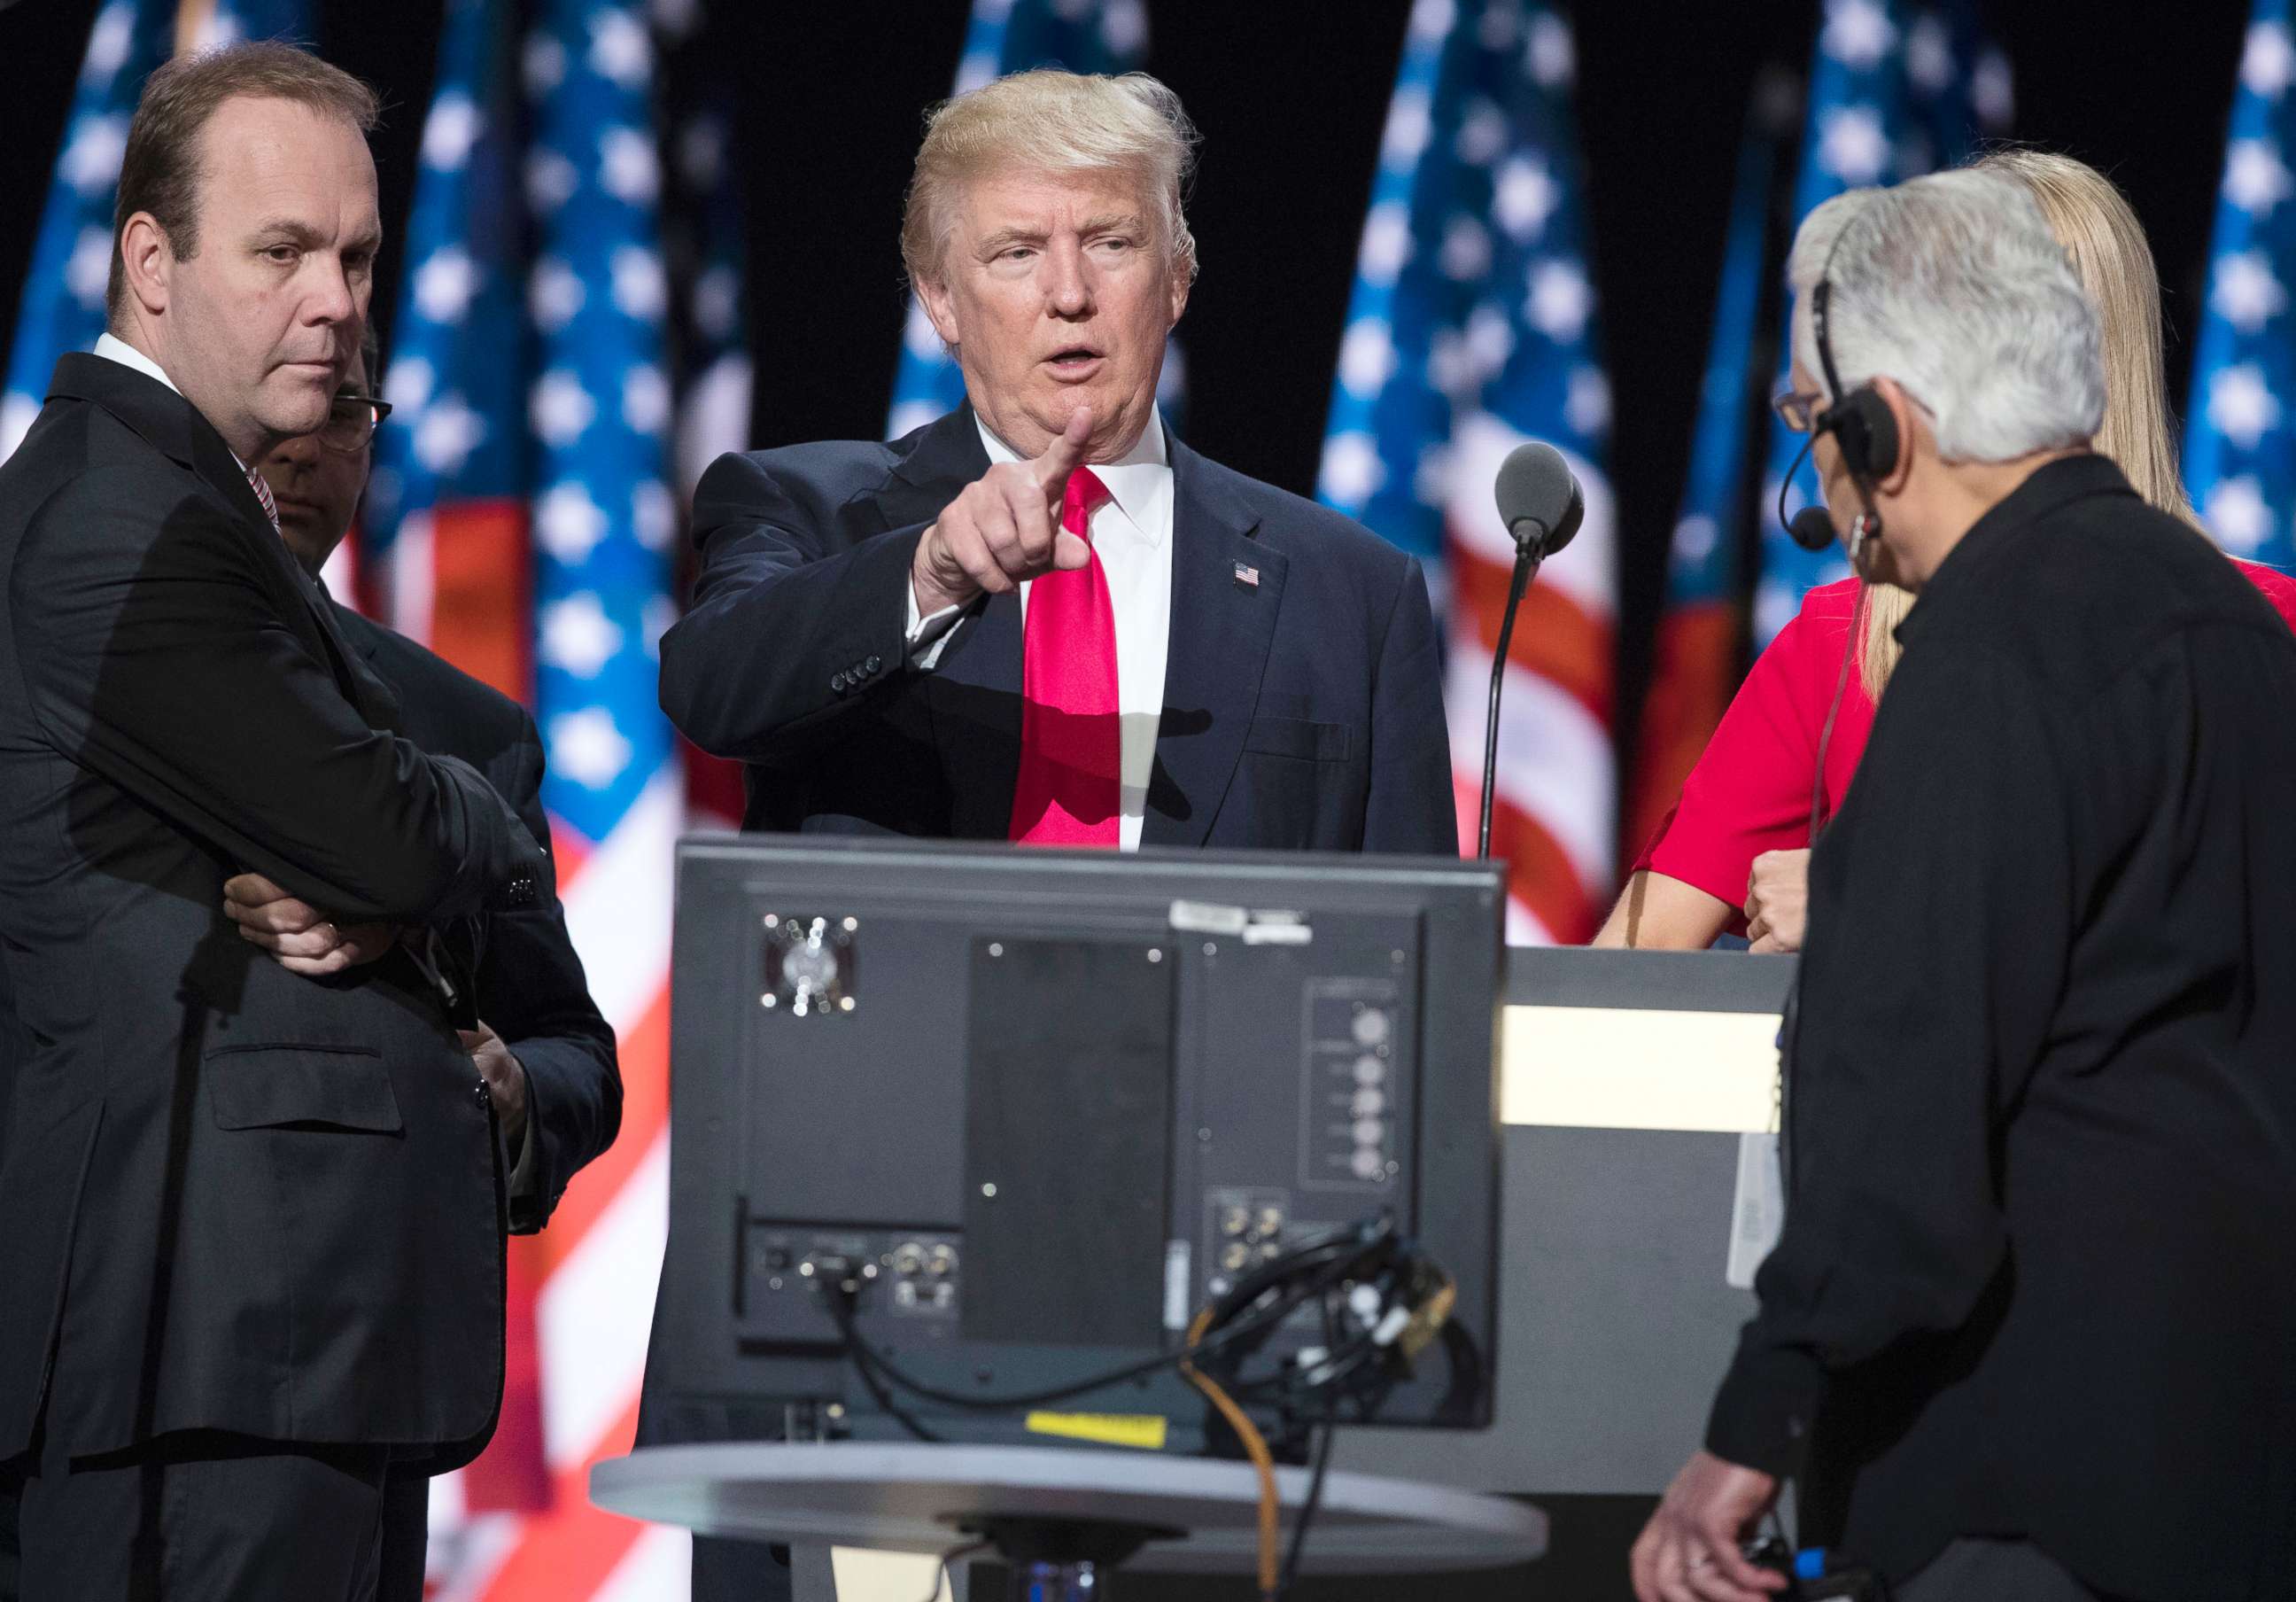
1633;172;2296;1602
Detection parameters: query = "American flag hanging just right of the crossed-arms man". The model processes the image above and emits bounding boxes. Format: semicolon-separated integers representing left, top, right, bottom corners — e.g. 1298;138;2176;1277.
348;0;684;1602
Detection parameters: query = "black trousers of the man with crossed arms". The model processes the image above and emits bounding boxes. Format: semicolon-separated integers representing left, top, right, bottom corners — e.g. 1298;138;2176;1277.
0;1430;430;1602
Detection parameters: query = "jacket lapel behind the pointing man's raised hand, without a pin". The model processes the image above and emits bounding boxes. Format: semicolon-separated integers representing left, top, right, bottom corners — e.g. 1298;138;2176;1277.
870;406;1021;840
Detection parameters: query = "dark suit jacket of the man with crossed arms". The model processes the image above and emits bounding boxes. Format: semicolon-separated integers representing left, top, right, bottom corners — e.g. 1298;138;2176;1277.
0;355;548;1459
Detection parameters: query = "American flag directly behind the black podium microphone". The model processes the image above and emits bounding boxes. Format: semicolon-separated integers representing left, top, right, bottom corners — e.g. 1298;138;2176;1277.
1318;0;1617;941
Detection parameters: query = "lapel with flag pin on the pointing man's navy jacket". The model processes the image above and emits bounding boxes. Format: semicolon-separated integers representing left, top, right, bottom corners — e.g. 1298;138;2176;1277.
1141;439;1288;844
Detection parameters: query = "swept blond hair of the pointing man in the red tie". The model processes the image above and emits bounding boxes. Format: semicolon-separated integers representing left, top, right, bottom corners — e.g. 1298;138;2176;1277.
900;66;1196;287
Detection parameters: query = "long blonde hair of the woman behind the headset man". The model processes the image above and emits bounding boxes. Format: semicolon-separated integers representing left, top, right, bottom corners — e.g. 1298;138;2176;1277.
1858;149;2199;700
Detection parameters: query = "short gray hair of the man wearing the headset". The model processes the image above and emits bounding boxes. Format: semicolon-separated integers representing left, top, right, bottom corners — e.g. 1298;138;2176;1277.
1788;170;2106;462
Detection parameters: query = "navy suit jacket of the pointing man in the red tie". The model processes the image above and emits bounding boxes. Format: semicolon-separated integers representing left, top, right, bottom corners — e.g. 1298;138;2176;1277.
661;406;1458;856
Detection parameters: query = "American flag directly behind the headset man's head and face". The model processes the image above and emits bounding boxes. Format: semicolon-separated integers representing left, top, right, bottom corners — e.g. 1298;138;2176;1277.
1754;0;2012;645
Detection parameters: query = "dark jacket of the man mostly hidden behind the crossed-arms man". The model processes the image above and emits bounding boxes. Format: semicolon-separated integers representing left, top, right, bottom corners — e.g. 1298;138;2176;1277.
335;606;622;1235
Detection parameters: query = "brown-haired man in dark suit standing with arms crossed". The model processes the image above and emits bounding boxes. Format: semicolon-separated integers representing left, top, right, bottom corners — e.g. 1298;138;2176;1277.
0;46;548;1602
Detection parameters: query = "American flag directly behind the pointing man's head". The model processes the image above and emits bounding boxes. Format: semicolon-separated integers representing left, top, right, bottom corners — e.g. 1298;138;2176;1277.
884;0;1180;439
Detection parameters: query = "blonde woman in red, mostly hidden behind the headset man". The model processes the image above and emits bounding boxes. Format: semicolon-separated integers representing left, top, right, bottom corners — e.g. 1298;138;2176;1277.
1594;149;2296;950
